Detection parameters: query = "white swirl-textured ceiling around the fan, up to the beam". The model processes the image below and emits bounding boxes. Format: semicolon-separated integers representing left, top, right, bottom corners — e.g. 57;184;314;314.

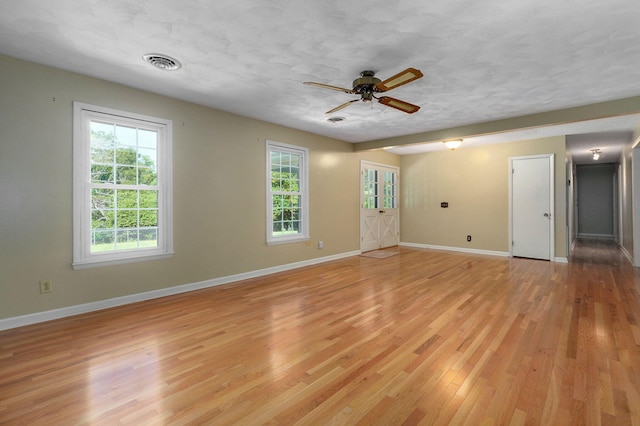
0;0;640;153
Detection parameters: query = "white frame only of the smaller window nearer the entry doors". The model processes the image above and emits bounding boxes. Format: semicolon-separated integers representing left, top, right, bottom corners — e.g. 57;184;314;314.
266;140;310;245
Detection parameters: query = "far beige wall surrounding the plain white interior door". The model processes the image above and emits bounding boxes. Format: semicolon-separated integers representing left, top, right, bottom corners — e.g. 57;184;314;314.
400;136;567;258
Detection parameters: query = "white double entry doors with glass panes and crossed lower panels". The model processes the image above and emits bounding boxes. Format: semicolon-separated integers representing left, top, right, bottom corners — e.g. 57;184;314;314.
360;161;400;252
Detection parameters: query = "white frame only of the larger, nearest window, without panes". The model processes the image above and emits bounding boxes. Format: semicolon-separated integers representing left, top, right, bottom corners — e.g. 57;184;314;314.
72;102;173;269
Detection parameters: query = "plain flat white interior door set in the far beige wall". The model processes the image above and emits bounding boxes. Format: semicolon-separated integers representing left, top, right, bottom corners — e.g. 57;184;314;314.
510;154;555;260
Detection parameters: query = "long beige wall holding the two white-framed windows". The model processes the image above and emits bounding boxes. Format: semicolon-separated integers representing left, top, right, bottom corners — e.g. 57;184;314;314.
0;56;400;319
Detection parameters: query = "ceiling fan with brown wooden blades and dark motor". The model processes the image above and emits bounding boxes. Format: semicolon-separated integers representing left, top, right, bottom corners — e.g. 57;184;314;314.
304;68;423;114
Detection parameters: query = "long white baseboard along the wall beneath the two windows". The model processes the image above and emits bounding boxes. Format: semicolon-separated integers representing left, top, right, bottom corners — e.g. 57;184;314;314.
0;250;360;330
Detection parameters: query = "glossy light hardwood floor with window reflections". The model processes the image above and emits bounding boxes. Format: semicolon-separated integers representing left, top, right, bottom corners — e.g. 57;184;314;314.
0;244;640;425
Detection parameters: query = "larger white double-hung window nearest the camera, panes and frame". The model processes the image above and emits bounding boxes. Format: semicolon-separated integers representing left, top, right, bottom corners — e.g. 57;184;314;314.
73;102;173;269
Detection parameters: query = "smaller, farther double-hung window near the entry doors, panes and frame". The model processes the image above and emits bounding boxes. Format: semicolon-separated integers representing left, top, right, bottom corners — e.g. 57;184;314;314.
267;141;309;244
